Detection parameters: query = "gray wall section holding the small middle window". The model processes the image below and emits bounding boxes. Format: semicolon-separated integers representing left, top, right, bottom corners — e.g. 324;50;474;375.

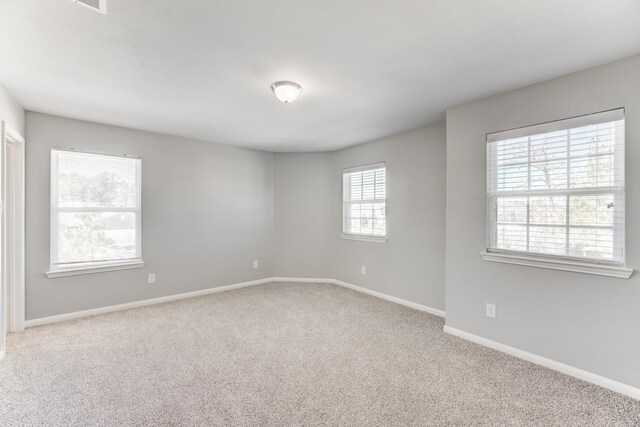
331;123;446;310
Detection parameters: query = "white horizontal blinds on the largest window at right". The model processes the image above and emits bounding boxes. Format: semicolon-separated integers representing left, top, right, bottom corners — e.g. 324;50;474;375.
487;109;624;264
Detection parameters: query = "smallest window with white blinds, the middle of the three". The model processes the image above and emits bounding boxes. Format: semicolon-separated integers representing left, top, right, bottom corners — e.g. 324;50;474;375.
342;163;387;242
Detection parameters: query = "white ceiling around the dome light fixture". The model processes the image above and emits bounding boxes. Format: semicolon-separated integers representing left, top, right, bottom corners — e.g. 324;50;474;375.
0;0;640;151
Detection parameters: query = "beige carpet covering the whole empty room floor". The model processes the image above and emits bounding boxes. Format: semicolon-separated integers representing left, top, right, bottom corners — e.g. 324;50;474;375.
0;283;640;426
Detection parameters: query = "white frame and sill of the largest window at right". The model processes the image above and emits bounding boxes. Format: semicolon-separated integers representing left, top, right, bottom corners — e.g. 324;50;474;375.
481;108;633;278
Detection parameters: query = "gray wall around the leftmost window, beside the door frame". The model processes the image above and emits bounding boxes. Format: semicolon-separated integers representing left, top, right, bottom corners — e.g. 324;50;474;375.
26;112;273;319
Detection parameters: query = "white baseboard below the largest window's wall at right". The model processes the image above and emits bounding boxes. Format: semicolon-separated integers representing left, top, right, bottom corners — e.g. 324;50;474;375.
443;325;640;400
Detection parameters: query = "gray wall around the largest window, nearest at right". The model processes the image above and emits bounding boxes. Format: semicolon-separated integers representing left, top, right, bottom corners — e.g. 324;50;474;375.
446;56;640;387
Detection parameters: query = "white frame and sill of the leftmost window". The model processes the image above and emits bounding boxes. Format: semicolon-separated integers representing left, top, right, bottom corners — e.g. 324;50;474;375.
45;147;144;278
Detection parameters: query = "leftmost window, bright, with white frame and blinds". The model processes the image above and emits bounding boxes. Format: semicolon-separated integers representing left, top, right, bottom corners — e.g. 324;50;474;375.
48;149;142;277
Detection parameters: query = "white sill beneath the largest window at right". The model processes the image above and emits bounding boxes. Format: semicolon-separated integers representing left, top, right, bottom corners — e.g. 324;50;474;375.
481;252;633;279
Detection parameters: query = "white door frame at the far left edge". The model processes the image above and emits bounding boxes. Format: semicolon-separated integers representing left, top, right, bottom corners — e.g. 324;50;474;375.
2;122;26;332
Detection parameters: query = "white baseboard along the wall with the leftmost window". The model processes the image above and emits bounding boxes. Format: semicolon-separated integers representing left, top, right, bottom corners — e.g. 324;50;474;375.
25;278;273;328
